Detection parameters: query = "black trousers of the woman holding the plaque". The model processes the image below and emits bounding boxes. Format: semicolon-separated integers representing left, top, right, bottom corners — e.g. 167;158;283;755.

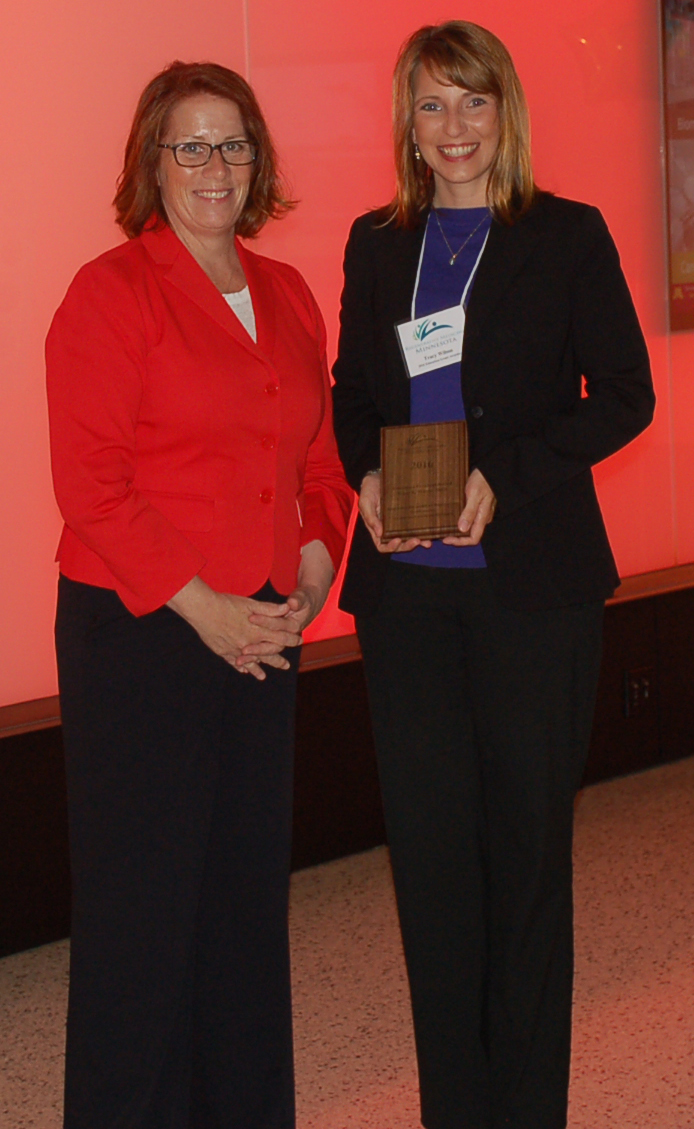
357;562;603;1129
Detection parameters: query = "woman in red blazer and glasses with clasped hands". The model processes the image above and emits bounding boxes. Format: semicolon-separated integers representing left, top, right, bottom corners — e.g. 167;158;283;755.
46;63;352;1129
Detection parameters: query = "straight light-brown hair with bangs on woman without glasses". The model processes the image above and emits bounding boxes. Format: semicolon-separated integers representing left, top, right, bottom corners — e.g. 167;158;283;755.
388;19;538;227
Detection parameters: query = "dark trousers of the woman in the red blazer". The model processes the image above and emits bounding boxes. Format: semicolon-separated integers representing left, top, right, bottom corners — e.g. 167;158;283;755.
56;578;299;1129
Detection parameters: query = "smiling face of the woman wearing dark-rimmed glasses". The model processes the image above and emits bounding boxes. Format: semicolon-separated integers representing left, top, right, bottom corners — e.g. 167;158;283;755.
158;94;253;244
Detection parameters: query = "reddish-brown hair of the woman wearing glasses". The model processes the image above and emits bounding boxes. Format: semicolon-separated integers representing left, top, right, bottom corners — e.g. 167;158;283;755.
113;60;293;239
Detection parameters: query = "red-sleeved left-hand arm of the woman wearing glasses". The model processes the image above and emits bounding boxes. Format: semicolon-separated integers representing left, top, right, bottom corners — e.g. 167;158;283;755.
46;262;205;615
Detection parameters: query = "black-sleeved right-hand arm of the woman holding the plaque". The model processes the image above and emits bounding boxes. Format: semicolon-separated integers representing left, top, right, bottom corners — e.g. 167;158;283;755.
476;208;655;515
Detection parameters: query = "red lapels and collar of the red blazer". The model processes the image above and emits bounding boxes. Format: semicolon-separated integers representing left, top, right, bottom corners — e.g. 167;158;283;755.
142;227;274;360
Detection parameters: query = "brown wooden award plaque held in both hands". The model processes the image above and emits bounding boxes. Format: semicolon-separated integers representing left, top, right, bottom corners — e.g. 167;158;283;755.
380;420;468;542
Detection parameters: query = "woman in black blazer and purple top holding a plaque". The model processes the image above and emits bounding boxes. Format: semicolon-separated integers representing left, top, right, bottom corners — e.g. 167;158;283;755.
334;21;653;1129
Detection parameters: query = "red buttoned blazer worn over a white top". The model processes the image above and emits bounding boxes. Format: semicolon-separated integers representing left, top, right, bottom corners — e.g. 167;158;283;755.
46;221;353;615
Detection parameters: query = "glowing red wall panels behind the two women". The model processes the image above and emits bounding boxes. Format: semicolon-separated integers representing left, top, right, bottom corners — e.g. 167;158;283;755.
0;0;694;706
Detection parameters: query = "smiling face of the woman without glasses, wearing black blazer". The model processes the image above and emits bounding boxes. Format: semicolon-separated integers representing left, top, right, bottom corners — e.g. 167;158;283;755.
412;67;500;208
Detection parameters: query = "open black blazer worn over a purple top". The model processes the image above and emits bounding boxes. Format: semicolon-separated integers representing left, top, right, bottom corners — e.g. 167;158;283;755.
333;193;655;615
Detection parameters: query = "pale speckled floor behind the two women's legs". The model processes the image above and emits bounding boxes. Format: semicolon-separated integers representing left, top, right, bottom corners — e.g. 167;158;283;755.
0;759;694;1129
